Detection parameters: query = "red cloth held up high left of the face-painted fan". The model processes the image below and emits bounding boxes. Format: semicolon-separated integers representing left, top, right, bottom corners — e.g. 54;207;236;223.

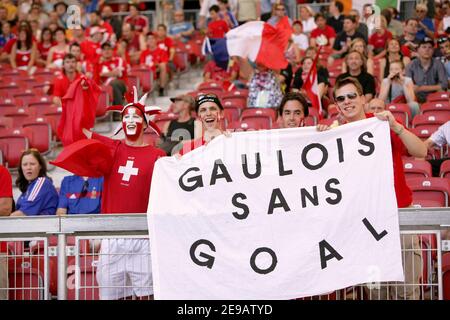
58;77;100;146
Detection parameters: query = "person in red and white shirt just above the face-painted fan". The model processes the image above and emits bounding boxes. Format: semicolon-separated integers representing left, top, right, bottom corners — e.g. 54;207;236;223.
97;42;127;105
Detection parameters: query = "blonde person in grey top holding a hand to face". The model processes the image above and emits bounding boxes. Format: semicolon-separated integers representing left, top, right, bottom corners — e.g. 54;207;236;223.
378;61;419;117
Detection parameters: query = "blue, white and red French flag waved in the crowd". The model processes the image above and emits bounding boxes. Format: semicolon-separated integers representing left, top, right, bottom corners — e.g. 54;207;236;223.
203;17;292;70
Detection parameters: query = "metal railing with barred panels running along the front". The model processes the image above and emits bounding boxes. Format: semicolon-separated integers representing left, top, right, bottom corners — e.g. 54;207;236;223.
0;208;450;300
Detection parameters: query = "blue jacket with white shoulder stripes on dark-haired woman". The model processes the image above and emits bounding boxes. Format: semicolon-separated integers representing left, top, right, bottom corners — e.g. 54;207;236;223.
16;177;58;216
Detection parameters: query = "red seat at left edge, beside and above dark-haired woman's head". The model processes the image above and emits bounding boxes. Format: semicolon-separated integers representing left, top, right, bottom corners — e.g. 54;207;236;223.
0;130;29;169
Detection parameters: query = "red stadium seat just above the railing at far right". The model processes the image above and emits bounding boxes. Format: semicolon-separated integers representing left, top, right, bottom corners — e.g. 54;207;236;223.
406;177;450;207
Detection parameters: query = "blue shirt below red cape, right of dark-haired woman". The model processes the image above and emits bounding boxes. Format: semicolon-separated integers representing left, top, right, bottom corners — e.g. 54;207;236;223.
58;176;103;214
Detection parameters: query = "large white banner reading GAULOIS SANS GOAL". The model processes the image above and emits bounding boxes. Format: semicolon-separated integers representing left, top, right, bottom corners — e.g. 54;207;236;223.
148;118;404;299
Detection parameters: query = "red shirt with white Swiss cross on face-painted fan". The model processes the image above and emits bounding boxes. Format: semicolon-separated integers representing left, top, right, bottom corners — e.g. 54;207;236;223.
92;133;166;213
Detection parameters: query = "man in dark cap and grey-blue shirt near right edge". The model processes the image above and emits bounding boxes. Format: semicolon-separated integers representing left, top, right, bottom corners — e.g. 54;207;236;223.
406;37;448;102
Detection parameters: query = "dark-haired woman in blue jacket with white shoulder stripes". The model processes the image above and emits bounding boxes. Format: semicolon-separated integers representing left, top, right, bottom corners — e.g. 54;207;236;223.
11;149;58;217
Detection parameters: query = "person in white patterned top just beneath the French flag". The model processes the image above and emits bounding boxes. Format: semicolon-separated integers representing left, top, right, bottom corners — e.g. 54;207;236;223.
247;63;283;108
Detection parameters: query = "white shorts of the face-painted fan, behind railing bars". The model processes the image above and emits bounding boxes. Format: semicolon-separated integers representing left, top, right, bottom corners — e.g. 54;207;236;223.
97;238;153;300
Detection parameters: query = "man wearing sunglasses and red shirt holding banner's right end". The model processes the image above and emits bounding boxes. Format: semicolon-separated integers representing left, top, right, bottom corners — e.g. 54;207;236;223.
317;77;427;299
